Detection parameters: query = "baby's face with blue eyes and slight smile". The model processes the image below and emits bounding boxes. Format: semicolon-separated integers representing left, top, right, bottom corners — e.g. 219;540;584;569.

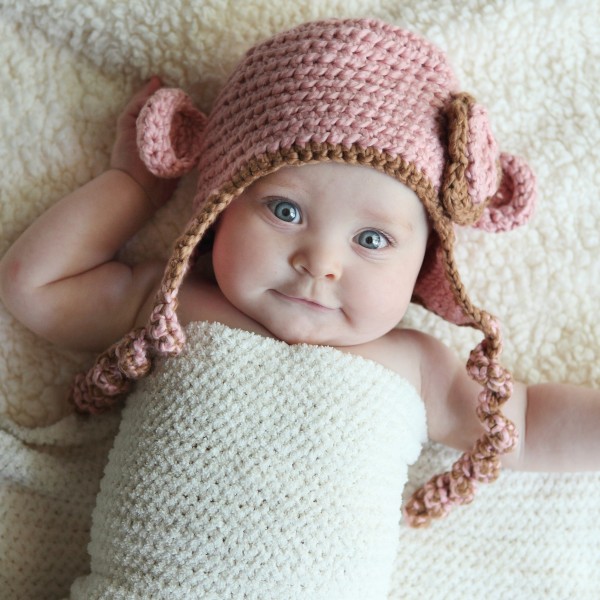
213;163;429;346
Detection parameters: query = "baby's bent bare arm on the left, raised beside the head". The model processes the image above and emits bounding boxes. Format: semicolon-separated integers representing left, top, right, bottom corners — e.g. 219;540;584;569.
0;78;171;350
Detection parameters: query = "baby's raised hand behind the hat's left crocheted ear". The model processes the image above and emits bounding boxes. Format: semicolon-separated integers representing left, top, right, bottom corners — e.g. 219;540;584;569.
110;76;177;208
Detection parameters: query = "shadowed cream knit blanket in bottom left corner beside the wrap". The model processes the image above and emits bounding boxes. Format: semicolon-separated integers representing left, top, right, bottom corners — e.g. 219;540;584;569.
0;412;120;600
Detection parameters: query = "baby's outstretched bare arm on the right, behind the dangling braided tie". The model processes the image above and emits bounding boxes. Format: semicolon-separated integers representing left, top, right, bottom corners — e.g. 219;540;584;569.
415;334;600;471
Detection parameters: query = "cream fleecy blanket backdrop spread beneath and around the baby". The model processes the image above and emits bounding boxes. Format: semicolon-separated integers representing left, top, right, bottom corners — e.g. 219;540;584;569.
0;0;600;600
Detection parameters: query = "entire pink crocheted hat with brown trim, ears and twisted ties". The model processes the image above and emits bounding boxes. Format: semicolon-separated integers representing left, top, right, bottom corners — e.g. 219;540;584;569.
73;19;535;525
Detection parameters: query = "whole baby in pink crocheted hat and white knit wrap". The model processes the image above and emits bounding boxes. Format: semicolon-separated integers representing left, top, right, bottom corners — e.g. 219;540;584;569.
0;20;600;600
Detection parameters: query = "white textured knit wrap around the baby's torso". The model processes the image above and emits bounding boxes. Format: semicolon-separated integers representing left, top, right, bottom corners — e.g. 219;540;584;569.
72;323;426;600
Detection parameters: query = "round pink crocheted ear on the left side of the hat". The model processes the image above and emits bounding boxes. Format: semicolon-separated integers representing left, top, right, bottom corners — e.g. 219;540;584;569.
136;88;206;177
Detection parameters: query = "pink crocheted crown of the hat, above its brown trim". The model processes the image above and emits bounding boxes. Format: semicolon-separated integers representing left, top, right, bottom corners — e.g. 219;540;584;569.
196;20;457;205
